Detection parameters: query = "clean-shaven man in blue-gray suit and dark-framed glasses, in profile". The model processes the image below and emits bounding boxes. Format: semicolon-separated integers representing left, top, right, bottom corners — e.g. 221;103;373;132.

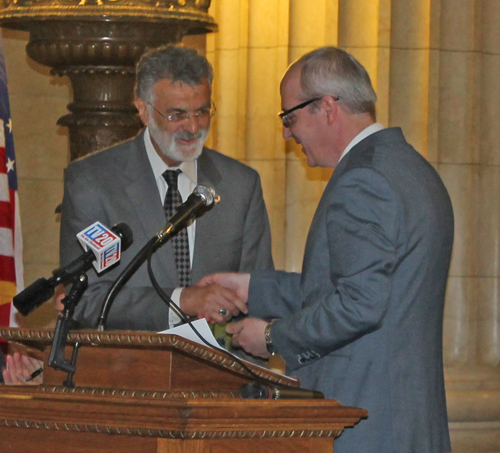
201;47;453;453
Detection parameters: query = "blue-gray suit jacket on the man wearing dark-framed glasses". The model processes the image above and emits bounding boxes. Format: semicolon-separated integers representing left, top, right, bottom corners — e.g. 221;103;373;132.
249;129;453;453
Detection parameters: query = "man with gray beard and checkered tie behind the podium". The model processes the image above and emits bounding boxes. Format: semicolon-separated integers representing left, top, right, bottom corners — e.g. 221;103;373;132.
60;46;273;331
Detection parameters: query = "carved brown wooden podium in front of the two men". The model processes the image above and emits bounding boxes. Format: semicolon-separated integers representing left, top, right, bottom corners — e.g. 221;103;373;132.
0;328;367;453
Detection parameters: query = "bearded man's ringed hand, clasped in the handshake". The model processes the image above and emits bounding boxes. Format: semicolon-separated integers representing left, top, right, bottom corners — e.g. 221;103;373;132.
180;283;248;324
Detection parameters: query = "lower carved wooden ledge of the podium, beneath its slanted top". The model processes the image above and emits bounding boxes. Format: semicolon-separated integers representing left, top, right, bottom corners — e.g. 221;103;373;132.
0;386;367;439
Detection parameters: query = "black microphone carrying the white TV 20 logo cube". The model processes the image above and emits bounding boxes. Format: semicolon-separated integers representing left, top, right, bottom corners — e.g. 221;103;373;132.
13;222;133;316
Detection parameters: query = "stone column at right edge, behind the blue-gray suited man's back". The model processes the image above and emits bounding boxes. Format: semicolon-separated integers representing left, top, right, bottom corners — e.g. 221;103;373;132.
437;0;500;452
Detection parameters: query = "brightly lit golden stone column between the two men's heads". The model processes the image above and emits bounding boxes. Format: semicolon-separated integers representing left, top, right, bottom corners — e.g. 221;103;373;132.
207;0;288;268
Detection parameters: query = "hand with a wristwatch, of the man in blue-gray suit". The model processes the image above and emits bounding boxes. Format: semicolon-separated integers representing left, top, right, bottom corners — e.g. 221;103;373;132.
226;318;270;358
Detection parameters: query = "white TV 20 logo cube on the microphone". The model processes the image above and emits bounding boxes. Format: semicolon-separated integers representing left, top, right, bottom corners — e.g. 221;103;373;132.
76;222;121;272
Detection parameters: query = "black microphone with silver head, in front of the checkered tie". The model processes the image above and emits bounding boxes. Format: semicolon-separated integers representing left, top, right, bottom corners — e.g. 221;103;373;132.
157;184;220;240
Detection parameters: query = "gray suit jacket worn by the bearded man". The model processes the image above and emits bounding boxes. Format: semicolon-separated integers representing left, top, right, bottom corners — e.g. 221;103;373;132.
60;129;273;331
